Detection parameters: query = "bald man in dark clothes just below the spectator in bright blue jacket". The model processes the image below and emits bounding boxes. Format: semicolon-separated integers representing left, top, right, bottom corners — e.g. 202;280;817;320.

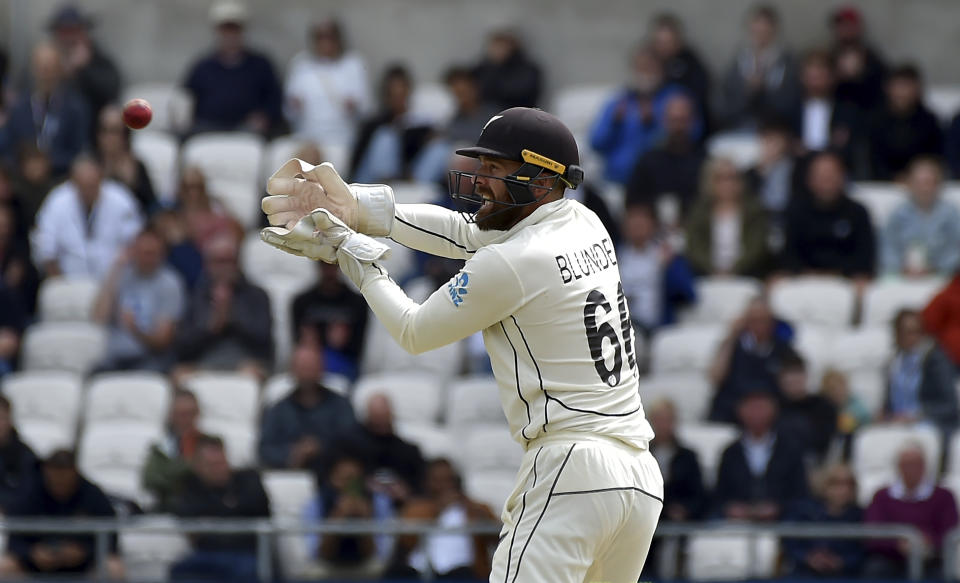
627;93;704;219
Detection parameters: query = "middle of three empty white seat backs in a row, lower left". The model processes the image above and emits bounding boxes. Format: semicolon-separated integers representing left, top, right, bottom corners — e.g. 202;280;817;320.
84;372;173;427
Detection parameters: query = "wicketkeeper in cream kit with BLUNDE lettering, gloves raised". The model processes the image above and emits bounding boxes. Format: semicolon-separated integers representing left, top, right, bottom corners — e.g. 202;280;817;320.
261;107;663;583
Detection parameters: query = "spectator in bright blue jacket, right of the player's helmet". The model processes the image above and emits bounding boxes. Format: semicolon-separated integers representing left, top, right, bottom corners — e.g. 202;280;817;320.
590;47;703;185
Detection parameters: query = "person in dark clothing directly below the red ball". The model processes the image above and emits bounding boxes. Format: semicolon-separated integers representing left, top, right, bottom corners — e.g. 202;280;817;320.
96;105;157;215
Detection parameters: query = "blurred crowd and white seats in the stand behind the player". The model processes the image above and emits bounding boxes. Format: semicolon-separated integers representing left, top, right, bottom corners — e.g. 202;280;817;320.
0;1;960;580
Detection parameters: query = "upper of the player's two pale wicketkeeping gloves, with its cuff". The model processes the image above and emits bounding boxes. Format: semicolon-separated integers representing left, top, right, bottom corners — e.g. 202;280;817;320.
260;158;394;236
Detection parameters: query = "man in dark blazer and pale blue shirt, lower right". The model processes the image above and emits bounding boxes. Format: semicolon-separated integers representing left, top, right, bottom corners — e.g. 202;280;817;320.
714;389;807;522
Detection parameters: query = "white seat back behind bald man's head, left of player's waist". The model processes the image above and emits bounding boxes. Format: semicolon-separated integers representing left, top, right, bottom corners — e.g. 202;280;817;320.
352;372;445;423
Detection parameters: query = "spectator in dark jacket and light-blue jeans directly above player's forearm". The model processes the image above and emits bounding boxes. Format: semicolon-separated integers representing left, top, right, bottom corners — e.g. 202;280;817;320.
350;65;433;183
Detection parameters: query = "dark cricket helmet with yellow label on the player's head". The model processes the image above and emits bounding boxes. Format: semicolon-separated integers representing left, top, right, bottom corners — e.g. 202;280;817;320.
457;107;583;184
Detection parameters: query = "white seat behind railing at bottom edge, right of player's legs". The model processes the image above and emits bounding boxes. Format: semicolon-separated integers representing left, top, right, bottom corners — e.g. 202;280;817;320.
687;530;779;581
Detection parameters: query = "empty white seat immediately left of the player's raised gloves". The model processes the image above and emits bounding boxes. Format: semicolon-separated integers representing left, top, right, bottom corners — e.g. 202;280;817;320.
181;132;264;228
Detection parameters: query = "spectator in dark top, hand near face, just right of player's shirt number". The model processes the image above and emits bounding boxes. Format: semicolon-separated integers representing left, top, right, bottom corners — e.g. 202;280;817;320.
710;298;796;423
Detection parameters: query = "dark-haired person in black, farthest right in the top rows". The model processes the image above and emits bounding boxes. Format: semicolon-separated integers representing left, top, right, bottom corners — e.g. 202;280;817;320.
867;65;943;180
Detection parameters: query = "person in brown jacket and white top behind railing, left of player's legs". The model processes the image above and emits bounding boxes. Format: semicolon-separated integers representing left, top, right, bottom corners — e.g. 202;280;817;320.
384;458;496;581
